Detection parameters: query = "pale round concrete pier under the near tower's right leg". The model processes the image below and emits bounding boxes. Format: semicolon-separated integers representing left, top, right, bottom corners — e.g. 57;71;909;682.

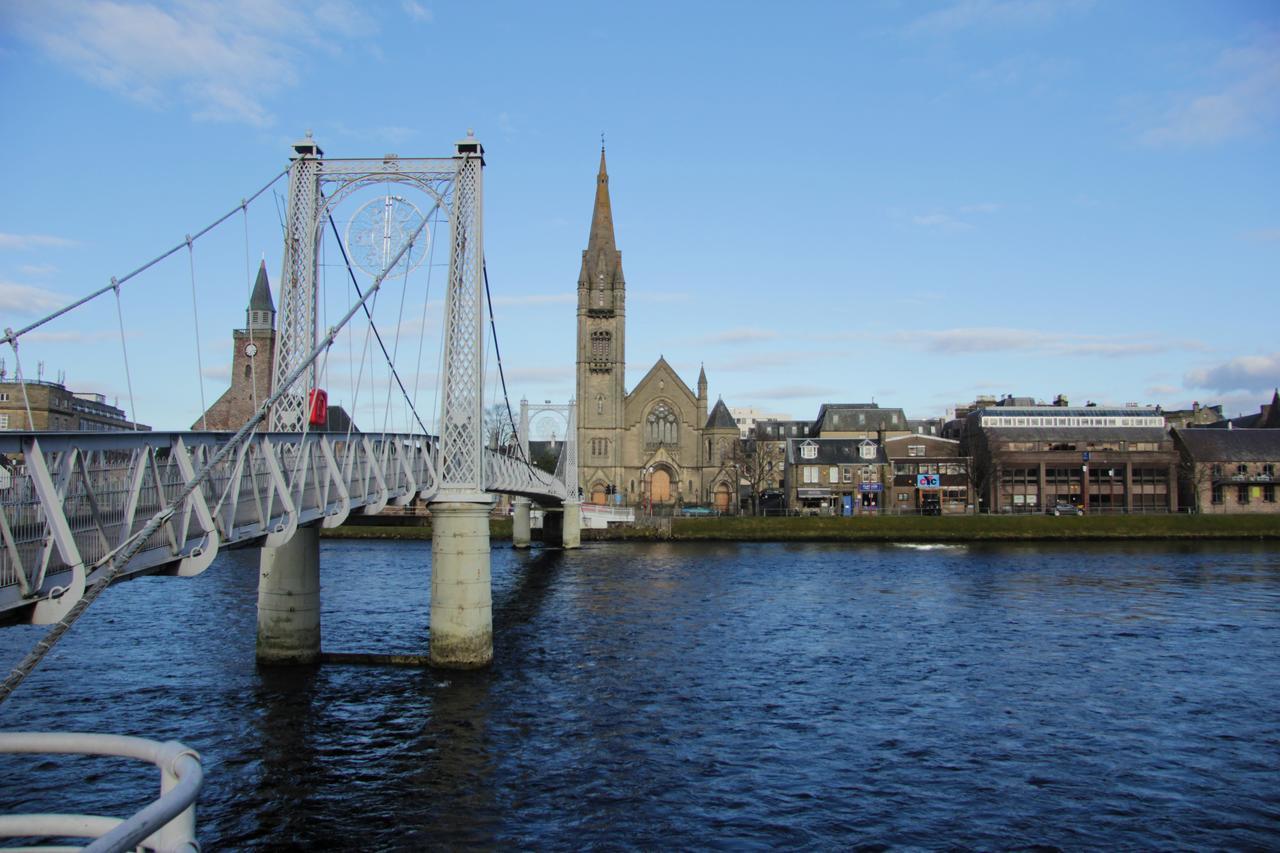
428;502;493;670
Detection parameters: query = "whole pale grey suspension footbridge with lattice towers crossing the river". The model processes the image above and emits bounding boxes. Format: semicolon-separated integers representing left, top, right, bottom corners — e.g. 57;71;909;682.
0;132;581;676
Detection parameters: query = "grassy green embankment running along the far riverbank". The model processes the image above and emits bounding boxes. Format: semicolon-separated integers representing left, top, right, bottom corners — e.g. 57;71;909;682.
324;515;1280;542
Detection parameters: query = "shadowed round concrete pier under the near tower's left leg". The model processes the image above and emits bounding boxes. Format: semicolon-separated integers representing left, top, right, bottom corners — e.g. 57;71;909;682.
257;526;320;663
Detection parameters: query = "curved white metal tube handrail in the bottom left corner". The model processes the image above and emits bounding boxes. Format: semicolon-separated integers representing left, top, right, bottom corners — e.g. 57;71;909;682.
0;731;204;853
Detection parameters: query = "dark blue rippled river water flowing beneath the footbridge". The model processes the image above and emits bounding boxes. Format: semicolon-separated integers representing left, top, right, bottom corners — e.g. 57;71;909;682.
0;540;1280;850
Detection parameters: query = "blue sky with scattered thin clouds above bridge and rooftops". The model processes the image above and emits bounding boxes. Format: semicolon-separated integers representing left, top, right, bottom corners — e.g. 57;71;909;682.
0;0;1280;429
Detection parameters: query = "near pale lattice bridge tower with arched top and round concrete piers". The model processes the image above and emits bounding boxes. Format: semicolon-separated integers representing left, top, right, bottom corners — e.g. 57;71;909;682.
257;131;493;669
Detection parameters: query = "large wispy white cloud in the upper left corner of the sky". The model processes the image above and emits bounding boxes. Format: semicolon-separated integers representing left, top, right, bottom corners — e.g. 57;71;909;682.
10;0;378;127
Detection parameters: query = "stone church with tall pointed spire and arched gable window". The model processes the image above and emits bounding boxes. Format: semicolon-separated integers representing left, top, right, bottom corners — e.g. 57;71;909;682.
576;147;739;511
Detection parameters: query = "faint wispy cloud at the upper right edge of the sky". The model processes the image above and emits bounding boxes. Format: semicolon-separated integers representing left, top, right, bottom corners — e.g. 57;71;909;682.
1140;35;1280;147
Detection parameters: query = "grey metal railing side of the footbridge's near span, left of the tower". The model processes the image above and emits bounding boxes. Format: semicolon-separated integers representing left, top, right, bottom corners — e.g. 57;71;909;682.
0;432;436;621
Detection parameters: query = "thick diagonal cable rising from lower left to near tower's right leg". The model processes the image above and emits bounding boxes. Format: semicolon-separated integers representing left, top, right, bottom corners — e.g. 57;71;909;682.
0;208;426;703
